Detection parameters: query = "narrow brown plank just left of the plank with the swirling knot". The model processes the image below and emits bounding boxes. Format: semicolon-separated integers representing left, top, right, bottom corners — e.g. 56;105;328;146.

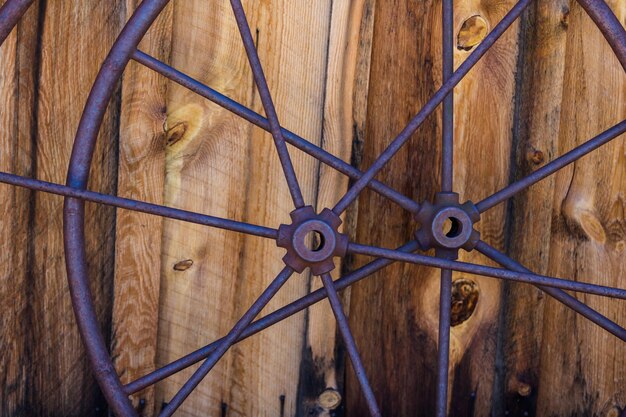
494;0;570;415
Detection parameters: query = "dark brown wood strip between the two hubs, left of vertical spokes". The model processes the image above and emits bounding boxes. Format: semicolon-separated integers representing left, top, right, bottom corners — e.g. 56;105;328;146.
346;1;439;416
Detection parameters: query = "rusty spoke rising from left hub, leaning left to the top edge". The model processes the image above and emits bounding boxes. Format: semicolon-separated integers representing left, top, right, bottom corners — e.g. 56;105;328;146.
230;0;304;208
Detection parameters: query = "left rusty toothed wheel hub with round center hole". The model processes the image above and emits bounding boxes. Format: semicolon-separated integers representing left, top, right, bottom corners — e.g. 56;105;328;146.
276;206;348;275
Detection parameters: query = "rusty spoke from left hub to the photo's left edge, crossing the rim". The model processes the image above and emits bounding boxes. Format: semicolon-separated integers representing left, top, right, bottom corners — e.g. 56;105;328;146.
0;172;278;239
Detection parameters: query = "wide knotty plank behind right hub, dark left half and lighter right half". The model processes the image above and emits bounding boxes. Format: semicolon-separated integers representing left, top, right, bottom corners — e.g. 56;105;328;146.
348;1;517;416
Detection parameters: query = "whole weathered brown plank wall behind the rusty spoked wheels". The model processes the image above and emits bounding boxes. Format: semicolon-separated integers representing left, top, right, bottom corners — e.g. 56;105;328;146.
0;0;626;417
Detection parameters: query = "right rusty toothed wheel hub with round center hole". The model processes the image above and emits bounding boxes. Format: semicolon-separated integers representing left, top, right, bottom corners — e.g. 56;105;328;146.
415;193;480;259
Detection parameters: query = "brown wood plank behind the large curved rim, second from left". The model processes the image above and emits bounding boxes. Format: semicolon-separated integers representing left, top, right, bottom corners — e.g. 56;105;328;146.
29;1;123;416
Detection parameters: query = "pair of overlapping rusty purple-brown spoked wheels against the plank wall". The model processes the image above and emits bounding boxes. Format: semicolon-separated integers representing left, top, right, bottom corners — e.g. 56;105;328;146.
0;0;626;417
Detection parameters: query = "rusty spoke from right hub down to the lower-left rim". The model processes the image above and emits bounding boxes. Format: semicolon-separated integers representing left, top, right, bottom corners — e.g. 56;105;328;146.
124;241;417;395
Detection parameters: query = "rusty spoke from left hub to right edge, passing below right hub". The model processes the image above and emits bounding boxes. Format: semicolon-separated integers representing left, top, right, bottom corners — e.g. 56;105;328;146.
348;243;626;300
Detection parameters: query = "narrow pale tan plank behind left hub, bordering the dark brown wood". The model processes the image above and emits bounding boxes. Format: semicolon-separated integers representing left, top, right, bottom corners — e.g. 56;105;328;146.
297;0;372;416
